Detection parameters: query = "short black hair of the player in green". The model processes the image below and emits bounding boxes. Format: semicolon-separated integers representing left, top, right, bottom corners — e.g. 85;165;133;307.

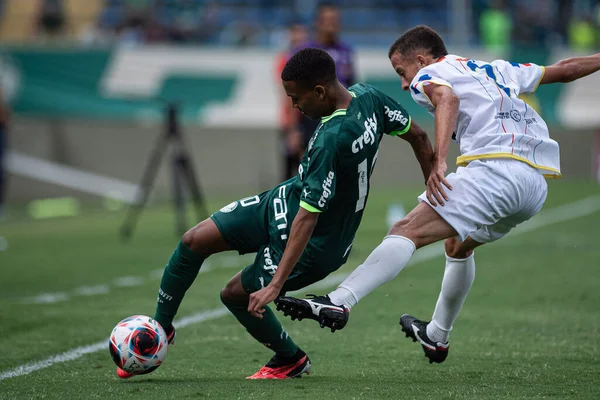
281;47;336;88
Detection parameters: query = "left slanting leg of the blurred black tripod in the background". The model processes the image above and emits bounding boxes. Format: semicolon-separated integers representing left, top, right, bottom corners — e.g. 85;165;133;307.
121;134;168;239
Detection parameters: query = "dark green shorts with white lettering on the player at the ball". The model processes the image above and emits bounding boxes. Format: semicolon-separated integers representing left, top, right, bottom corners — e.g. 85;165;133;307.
211;181;341;293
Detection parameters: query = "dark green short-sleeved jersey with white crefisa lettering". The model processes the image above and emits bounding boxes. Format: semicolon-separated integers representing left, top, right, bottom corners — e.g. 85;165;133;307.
287;84;411;267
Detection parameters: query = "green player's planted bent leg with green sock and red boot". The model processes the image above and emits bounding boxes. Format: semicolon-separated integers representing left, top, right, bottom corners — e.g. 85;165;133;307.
221;267;311;379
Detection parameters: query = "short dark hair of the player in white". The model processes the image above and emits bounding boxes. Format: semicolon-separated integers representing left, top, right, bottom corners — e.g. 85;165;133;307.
388;25;448;58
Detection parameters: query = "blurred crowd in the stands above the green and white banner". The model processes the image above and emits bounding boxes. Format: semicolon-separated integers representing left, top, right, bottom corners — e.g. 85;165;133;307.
0;0;600;49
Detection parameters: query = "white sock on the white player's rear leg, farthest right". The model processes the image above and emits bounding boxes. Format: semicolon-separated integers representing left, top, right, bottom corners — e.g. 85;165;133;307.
427;254;475;343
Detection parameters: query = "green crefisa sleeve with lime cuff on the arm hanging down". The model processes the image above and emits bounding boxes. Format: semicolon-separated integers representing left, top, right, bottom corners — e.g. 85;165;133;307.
300;146;337;212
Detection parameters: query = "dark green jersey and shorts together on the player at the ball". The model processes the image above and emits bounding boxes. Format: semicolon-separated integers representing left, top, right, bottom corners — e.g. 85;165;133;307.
211;84;410;293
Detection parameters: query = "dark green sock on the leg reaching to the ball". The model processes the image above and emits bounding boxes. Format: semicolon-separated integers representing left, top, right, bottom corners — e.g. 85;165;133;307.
154;241;208;329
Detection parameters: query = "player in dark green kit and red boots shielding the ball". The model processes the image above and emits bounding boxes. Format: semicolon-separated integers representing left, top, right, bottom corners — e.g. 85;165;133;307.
117;48;433;379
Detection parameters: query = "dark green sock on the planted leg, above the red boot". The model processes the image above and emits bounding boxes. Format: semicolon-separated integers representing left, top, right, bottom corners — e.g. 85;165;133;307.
221;290;298;357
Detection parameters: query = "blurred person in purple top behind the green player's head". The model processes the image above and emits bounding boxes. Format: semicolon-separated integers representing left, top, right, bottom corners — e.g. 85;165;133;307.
298;2;356;167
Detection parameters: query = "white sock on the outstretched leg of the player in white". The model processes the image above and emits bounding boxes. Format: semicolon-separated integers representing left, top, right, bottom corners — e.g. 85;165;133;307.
329;235;418;308
